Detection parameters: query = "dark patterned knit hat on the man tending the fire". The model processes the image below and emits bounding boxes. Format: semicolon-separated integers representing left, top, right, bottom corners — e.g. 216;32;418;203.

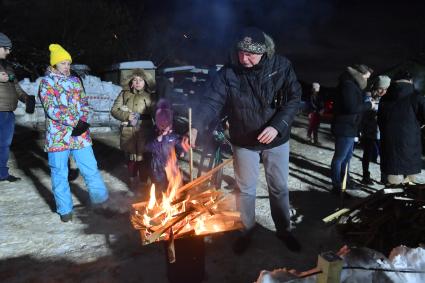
237;27;266;54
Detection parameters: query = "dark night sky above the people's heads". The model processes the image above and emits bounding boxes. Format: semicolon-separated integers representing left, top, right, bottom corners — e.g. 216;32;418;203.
0;0;425;86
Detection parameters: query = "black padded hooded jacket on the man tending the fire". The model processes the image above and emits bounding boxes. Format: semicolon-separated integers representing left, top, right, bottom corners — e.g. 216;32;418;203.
194;36;301;150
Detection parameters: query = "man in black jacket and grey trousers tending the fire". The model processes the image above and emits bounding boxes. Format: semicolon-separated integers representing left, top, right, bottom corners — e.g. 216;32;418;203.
191;28;301;254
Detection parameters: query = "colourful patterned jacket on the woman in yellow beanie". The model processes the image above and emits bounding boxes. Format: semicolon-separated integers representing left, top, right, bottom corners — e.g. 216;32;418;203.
39;69;92;152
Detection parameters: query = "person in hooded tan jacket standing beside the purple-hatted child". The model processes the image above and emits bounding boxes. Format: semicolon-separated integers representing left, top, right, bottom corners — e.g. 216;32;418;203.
111;69;156;189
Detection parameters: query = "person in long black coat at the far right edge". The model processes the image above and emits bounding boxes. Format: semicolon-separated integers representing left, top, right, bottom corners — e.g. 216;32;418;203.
378;70;425;186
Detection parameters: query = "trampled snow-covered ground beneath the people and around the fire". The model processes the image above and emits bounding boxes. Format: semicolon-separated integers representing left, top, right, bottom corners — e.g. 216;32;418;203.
0;117;425;282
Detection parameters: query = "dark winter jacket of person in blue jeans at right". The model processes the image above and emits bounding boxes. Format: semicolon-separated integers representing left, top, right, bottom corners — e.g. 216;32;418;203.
332;72;372;137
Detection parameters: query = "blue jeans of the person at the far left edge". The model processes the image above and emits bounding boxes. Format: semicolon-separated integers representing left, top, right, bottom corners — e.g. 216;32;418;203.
0;111;15;179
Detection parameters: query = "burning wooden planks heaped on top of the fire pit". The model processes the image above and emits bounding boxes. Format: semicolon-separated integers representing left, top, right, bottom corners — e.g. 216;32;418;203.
131;160;242;248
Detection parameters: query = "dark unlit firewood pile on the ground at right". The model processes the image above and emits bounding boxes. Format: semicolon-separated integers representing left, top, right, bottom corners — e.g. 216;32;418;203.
323;185;425;254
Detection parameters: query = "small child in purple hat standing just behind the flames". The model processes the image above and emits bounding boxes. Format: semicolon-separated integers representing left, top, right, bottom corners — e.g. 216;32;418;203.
146;99;190;192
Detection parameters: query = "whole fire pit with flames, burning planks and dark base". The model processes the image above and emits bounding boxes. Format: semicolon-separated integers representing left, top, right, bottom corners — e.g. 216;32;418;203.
131;151;243;282
